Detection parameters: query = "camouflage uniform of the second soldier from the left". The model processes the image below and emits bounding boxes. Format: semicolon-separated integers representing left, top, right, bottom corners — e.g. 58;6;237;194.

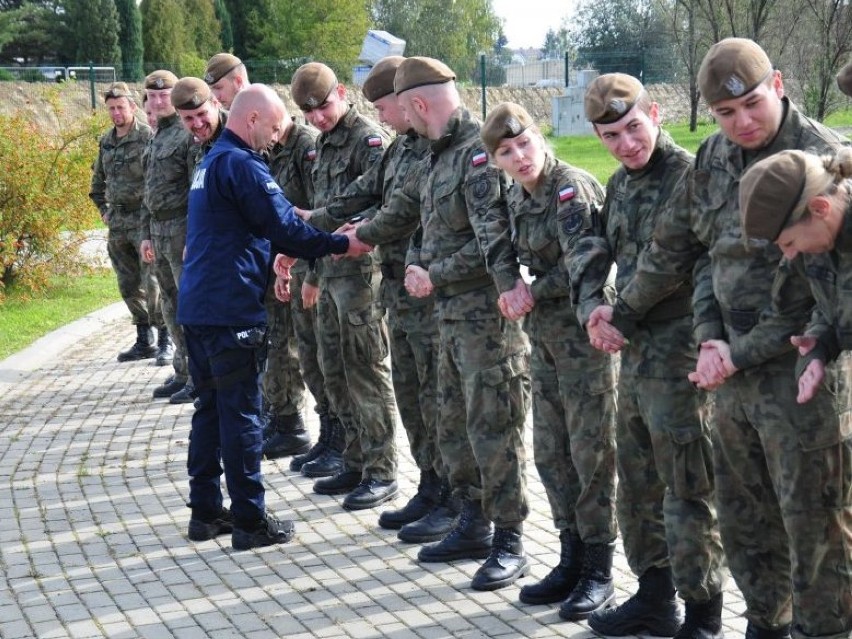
142;113;199;381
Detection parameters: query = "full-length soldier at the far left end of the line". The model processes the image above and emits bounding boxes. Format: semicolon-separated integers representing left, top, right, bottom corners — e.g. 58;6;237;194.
89;82;166;364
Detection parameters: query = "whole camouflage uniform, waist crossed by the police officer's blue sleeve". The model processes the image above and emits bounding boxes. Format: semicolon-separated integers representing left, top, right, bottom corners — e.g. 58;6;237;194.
311;106;396;481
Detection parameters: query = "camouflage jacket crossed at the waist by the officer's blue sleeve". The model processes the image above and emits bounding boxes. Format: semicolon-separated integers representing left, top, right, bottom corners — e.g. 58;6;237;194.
311;106;389;277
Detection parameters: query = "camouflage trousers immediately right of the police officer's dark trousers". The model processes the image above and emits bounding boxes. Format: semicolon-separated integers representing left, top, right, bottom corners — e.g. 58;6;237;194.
263;277;305;416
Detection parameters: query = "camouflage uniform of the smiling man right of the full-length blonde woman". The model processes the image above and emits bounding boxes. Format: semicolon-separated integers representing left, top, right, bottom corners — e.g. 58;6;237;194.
577;131;724;601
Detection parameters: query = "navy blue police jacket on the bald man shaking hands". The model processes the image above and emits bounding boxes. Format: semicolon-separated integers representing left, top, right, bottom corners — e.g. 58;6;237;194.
177;129;349;326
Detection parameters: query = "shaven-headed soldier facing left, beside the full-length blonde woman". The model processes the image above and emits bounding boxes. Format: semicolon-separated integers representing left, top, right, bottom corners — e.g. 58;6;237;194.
394;57;530;590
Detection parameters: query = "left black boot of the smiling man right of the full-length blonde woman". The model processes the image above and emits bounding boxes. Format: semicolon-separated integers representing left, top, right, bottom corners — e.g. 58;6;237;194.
589;566;683;637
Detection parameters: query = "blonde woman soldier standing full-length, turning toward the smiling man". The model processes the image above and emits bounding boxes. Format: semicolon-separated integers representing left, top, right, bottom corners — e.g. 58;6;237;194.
481;102;618;620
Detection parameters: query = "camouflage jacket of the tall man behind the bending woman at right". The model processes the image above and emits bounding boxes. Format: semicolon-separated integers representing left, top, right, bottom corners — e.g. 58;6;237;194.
617;98;844;369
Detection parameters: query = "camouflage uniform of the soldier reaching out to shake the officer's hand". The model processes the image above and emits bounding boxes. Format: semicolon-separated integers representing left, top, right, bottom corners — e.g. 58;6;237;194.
315;132;442;475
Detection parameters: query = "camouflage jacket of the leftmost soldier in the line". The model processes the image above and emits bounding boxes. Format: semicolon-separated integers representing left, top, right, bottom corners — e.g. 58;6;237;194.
89;118;151;230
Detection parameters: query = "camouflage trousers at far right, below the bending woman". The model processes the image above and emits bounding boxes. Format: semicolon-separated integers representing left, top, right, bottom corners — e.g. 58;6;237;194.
713;351;852;639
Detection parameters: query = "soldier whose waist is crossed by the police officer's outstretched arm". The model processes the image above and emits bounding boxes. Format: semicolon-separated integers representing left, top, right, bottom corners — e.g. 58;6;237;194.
292;62;399;510
